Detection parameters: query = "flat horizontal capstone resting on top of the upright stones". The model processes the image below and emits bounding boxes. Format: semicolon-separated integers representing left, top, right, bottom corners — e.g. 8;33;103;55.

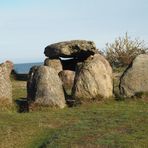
44;40;98;59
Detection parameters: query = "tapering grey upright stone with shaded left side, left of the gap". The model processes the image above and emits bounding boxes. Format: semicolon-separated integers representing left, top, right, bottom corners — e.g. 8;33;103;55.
27;66;66;108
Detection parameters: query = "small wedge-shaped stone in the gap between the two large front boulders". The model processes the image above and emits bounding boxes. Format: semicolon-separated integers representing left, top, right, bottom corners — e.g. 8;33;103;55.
59;70;75;95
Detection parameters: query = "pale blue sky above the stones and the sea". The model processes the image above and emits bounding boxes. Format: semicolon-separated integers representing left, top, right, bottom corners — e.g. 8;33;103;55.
0;0;148;63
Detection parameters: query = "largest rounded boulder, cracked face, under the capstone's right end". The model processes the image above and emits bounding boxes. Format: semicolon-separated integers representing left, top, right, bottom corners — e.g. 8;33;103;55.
72;54;113;103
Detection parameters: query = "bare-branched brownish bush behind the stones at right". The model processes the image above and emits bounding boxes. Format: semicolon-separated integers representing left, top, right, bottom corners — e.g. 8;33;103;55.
105;33;148;67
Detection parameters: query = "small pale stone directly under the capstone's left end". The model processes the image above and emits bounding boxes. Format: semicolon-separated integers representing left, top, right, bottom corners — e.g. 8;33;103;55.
44;58;63;73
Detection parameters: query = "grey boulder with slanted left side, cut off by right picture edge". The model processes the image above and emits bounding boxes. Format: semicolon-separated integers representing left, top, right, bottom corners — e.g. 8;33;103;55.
119;54;148;97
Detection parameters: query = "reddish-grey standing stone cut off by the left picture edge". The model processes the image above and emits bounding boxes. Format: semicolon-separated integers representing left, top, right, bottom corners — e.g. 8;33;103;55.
0;61;13;106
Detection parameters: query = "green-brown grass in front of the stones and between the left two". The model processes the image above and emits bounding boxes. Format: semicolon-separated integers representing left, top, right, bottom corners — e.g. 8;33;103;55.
0;81;148;148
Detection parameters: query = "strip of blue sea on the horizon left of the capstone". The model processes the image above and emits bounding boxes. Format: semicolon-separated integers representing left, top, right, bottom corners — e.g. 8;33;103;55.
14;62;43;74
